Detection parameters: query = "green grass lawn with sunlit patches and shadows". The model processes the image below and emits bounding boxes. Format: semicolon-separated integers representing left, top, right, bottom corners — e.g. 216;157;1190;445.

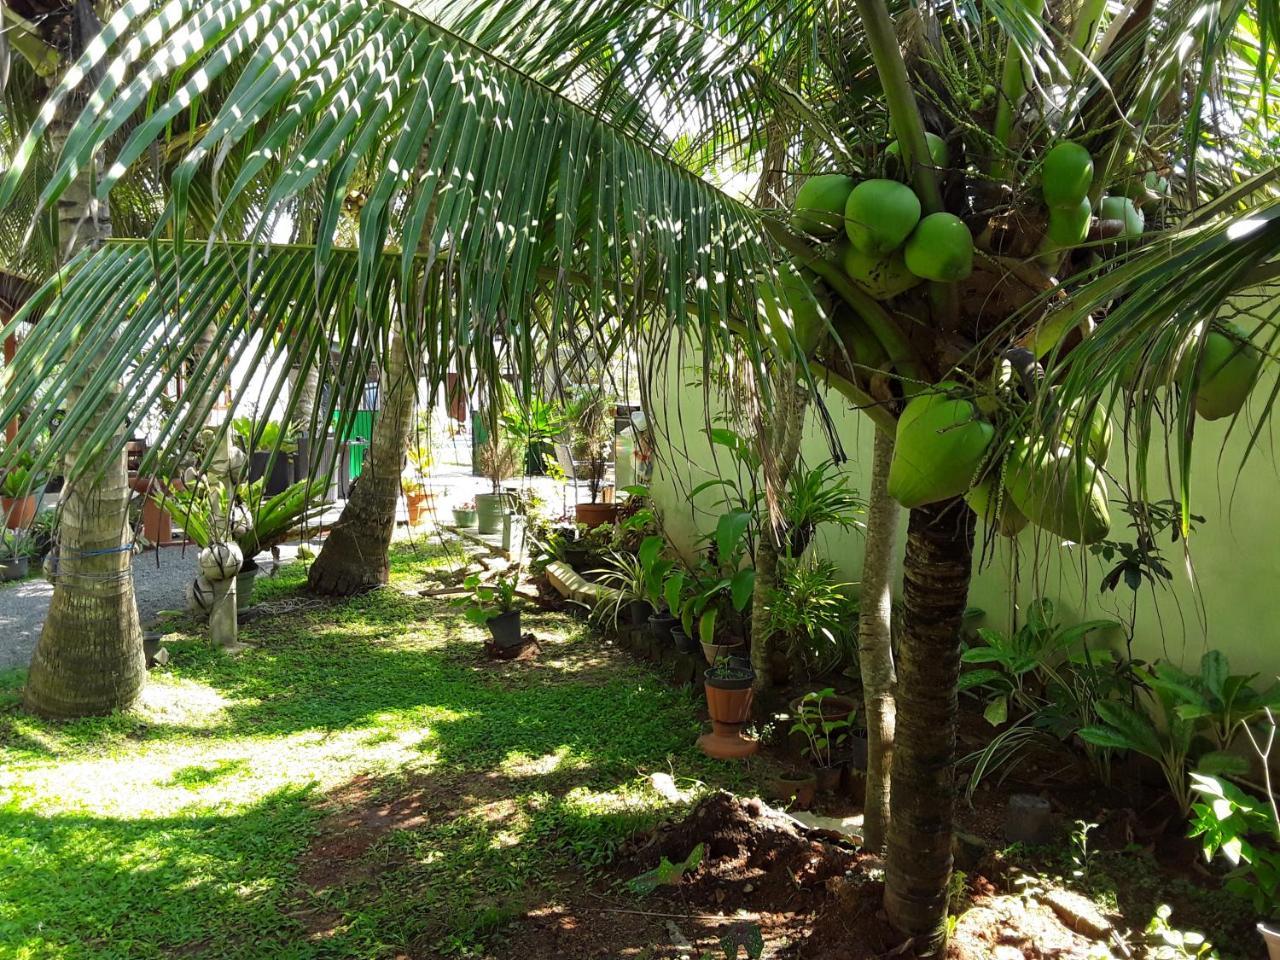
0;548;733;960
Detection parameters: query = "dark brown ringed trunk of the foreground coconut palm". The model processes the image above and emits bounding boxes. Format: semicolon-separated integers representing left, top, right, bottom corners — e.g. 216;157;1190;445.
884;498;974;956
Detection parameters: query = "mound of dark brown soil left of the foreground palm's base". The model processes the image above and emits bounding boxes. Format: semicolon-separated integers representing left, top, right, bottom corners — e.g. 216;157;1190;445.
618;792;859;911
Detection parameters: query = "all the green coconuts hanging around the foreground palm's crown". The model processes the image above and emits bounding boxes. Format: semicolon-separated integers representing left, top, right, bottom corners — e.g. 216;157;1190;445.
759;133;1261;544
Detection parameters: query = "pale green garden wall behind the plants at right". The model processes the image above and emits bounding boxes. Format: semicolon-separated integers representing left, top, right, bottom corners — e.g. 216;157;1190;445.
650;352;1280;675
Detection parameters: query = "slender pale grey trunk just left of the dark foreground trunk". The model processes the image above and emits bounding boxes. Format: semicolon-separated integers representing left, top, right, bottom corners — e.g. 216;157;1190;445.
858;429;901;851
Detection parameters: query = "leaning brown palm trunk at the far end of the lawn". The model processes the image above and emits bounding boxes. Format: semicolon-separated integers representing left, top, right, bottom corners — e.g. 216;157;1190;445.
307;329;417;596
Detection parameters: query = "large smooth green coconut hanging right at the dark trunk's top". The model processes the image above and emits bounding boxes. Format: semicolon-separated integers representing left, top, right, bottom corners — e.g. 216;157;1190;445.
888;383;996;508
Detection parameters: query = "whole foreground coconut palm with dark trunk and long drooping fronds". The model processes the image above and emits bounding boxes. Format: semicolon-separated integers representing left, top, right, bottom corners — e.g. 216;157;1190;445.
0;0;1280;954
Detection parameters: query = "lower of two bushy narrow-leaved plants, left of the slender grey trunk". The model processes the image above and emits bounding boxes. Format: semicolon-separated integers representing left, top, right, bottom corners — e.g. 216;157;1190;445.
765;557;858;676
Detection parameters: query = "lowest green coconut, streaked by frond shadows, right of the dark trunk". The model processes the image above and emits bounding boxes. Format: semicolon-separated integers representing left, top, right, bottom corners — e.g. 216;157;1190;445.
1005;438;1111;544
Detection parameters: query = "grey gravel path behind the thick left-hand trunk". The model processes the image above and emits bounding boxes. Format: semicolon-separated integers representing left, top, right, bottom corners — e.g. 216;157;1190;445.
0;544;308;669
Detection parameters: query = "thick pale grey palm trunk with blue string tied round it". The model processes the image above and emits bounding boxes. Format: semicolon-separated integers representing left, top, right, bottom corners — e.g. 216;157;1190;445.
24;102;146;717
